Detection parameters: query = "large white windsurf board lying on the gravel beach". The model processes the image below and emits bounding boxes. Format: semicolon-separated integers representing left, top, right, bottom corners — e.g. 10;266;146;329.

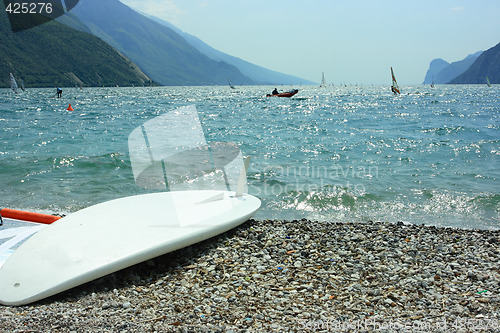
0;190;261;305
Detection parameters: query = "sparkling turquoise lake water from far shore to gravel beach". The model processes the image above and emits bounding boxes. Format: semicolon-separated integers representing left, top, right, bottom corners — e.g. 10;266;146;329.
0;85;500;229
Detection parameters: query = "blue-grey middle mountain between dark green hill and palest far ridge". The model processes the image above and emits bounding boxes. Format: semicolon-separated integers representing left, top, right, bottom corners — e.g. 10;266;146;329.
63;0;255;85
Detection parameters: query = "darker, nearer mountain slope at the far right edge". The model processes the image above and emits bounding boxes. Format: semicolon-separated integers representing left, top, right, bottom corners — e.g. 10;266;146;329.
450;43;500;84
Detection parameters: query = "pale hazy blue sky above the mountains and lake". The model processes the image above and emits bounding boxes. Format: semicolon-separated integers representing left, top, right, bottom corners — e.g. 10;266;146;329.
120;0;500;85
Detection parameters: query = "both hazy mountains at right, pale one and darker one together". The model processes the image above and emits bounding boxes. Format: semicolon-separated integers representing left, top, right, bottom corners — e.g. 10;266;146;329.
423;44;500;84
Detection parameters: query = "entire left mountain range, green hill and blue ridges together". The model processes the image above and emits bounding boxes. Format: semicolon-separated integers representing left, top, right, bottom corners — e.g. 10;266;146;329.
0;0;313;87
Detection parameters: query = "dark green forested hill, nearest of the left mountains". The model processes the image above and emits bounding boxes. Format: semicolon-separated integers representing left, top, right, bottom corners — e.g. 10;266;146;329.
0;2;151;87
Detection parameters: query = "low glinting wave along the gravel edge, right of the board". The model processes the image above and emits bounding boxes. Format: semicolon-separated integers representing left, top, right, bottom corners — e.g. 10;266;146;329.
253;187;500;229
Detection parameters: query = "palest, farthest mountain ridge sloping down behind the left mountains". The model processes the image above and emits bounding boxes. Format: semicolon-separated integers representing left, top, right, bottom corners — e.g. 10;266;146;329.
147;15;316;85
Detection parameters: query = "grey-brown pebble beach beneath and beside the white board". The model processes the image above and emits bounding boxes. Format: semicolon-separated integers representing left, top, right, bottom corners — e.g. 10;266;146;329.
0;220;500;332
